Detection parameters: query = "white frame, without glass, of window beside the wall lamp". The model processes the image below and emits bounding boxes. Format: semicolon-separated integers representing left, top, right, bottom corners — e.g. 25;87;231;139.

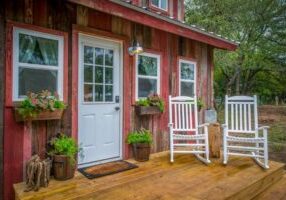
135;52;161;101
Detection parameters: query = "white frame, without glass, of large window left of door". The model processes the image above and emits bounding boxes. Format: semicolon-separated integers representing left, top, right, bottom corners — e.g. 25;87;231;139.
12;27;65;102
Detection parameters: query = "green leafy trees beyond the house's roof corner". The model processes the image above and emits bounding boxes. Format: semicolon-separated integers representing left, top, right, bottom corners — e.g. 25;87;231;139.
185;0;286;103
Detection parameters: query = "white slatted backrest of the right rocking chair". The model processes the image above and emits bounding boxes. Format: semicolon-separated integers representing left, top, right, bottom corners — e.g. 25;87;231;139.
225;96;258;133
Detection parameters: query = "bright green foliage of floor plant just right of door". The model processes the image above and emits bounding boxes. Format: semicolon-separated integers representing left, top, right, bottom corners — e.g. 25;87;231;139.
127;129;152;144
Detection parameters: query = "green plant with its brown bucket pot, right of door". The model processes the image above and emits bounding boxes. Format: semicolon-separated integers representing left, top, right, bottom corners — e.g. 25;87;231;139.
127;129;152;162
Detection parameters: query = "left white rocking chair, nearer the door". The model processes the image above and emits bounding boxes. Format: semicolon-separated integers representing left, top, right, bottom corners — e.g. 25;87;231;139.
169;96;210;164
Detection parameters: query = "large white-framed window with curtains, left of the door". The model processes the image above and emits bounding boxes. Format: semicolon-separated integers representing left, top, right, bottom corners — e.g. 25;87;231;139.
13;28;63;101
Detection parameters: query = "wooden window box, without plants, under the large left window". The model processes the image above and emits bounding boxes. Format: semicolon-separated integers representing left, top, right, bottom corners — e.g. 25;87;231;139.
15;108;64;122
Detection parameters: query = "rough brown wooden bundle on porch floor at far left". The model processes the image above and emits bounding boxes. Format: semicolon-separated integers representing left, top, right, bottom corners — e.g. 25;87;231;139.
25;155;52;192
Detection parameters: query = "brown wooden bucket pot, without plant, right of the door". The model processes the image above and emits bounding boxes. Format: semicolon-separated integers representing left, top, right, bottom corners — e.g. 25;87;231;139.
132;143;151;162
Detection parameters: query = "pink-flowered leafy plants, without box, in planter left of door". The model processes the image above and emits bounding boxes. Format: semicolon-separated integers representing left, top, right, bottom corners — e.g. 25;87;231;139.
17;90;66;119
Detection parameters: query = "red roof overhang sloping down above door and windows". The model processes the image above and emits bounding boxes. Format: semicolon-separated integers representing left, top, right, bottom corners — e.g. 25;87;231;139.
68;0;238;51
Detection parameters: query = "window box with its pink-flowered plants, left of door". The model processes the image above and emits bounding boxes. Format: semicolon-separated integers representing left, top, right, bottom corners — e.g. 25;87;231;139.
15;90;66;122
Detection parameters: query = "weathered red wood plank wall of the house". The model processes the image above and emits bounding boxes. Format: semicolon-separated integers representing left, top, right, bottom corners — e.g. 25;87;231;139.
0;0;213;200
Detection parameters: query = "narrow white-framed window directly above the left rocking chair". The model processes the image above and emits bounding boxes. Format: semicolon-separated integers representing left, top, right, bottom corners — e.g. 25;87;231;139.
179;59;196;96
